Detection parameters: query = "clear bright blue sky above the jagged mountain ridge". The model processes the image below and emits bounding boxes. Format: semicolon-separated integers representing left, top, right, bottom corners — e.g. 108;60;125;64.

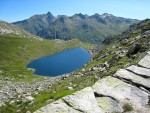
0;0;150;22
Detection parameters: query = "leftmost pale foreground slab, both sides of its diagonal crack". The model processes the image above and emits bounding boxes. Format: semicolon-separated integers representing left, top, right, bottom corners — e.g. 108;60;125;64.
34;87;104;113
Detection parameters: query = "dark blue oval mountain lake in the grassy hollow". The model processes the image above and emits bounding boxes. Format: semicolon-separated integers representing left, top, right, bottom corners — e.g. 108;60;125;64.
27;48;90;77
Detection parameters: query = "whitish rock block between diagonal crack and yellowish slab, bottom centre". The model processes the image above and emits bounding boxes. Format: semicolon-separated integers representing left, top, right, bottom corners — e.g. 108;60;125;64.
63;87;103;113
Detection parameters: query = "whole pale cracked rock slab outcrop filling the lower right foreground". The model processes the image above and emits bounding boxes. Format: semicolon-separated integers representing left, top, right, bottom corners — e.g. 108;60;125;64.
34;51;150;113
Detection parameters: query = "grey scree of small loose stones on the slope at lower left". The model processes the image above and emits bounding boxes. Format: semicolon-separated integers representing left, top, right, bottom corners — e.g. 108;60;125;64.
0;74;69;106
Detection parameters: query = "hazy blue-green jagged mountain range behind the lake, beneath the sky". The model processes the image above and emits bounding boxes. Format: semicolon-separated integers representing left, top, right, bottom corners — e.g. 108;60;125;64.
13;12;139;43
